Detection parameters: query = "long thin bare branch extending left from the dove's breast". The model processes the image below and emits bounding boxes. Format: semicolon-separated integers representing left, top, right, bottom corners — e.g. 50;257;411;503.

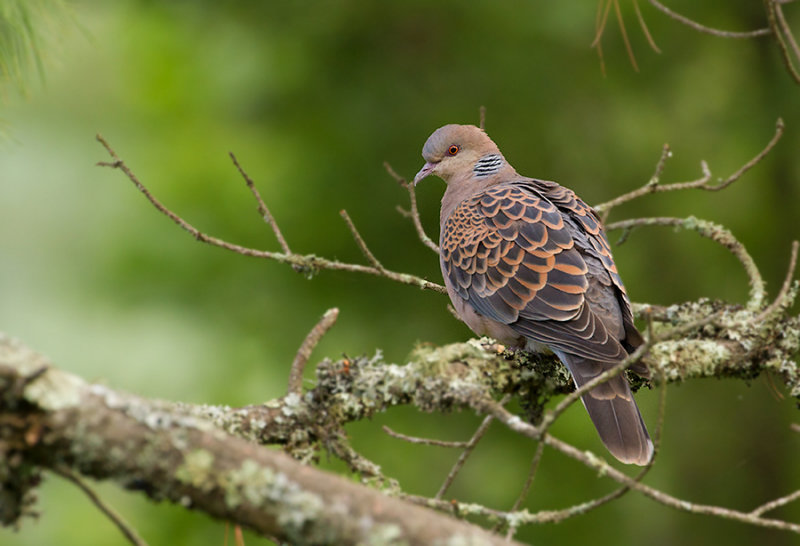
97;135;447;294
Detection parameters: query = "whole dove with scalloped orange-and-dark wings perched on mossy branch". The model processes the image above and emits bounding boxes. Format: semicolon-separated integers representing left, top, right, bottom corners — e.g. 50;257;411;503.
413;124;653;465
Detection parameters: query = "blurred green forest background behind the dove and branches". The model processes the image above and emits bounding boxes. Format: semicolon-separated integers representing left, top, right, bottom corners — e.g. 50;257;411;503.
0;0;800;546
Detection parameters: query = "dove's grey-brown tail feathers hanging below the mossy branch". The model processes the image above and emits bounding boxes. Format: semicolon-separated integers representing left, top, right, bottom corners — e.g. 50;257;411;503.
558;352;653;465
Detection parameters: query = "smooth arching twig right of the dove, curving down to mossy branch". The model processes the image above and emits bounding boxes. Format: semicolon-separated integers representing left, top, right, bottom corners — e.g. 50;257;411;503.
606;216;766;309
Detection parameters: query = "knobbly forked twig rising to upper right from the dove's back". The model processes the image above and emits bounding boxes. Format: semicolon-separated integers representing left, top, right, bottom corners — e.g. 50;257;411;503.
594;118;784;219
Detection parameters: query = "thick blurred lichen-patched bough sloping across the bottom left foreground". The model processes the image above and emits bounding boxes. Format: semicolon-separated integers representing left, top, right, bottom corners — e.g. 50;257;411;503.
0;336;520;545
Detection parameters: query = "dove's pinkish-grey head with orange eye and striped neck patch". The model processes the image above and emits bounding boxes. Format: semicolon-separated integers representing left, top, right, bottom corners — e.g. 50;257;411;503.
414;124;505;185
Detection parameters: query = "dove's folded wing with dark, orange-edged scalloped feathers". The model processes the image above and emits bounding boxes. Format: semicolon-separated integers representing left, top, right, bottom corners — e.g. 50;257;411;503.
441;180;635;362
